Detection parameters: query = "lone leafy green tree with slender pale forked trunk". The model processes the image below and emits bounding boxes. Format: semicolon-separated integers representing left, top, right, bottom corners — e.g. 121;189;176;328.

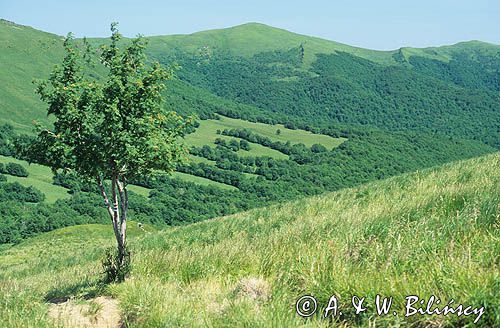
28;23;190;281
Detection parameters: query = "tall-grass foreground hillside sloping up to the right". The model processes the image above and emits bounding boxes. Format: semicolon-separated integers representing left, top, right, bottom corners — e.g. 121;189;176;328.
0;153;500;327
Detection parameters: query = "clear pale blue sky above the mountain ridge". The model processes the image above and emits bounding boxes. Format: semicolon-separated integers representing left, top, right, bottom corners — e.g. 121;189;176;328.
0;0;500;49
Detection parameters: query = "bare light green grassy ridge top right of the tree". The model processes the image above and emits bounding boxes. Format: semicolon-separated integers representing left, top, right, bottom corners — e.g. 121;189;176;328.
114;22;500;65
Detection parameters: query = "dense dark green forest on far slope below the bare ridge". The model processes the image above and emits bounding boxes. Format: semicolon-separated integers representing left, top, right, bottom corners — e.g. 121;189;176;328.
160;46;500;148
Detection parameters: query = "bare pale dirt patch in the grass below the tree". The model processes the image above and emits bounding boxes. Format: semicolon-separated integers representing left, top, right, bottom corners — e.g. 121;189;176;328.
49;296;121;328
